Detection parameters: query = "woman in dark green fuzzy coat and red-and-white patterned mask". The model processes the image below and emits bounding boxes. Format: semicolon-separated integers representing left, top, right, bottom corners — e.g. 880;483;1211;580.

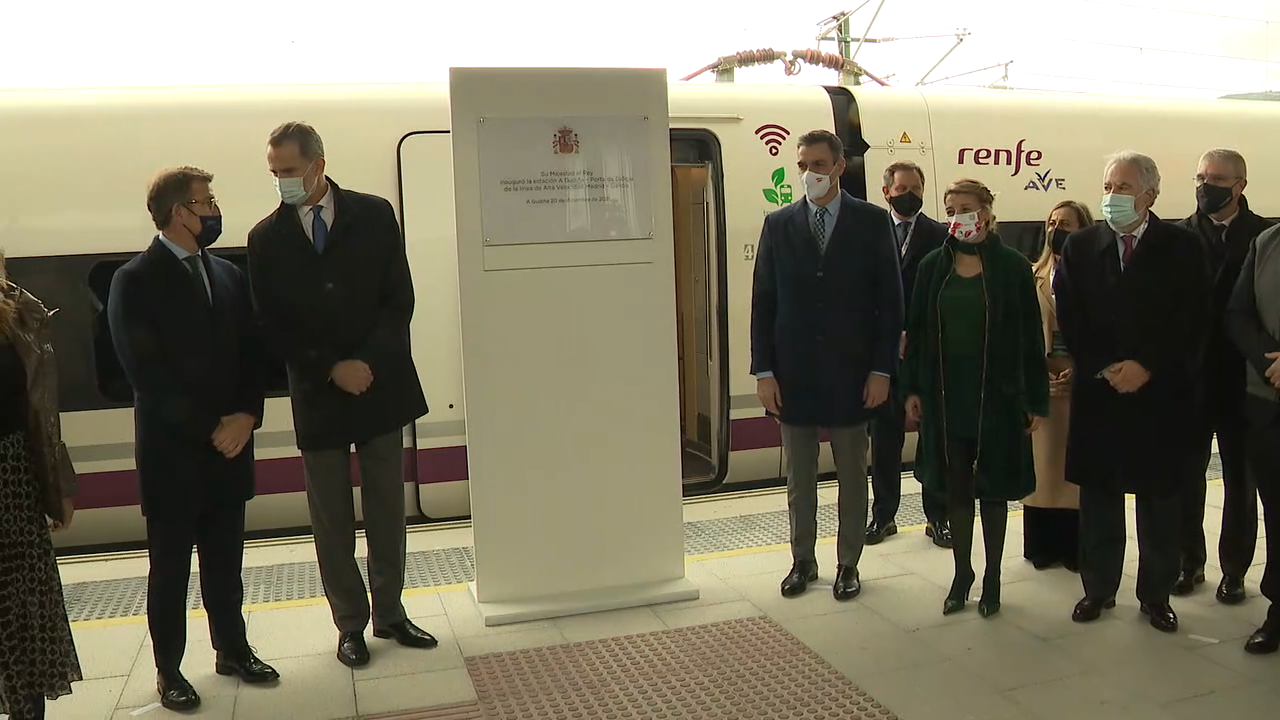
901;179;1048;618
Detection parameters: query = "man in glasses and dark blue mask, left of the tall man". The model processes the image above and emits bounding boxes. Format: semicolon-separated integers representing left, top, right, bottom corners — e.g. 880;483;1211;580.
108;168;279;710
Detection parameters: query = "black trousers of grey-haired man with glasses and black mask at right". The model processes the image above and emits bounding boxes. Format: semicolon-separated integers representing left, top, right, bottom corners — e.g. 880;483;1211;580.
1180;414;1258;578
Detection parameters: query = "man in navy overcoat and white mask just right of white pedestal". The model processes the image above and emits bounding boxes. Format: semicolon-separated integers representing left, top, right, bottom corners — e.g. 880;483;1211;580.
751;131;904;600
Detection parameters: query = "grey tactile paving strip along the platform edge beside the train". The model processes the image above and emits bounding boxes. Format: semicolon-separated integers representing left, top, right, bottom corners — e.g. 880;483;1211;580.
63;454;1222;623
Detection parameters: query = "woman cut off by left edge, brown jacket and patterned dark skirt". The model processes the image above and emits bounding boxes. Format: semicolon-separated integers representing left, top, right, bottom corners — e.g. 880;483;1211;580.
0;255;82;720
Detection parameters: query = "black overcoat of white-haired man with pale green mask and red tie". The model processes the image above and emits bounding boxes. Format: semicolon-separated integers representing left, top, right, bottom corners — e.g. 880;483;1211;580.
1053;213;1211;493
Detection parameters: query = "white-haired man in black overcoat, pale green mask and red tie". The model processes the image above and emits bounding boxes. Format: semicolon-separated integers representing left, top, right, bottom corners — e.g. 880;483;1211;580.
1053;151;1210;632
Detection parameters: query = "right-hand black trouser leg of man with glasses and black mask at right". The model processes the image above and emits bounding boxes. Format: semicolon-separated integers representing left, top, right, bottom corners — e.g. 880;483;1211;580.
1217;415;1258;578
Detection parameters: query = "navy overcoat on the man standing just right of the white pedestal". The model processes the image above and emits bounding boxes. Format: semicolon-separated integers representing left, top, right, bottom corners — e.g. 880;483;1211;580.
751;191;904;428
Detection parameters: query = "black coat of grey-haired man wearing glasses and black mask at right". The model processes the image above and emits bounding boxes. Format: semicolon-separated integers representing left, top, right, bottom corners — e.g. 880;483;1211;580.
1179;197;1272;423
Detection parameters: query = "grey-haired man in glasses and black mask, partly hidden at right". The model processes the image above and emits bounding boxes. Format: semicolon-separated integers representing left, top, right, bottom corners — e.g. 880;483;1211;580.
1174;149;1271;605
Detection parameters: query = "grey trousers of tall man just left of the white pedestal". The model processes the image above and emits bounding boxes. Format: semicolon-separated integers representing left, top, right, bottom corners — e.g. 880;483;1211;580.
302;430;406;633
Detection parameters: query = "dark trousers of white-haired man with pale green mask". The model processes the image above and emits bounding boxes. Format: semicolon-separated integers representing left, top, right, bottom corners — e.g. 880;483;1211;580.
1080;483;1180;605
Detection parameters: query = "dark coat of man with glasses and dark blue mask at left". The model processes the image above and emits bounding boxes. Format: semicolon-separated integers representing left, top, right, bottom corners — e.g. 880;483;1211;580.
106;237;266;518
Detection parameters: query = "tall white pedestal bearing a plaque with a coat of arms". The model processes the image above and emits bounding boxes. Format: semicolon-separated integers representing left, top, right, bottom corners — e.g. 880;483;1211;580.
449;68;698;625
